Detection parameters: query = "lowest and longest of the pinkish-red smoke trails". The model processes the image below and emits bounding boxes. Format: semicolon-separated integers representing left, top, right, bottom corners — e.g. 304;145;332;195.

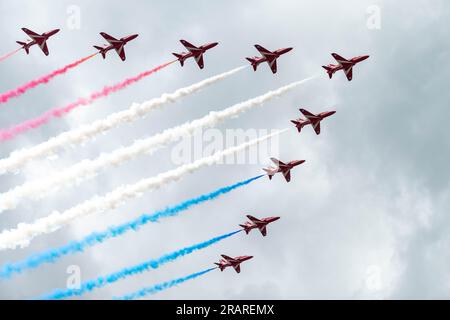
0;60;176;141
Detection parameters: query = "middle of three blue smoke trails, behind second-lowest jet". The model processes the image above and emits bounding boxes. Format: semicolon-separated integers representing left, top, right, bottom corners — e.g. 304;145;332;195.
43;230;242;300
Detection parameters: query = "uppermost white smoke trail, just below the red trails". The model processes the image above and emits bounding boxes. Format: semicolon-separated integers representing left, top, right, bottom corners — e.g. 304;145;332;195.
0;66;246;174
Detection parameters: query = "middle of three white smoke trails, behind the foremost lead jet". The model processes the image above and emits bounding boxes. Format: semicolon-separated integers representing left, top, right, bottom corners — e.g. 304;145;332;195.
0;78;312;212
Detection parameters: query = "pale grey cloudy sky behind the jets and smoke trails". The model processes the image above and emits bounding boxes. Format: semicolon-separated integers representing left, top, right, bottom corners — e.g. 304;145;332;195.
0;0;450;299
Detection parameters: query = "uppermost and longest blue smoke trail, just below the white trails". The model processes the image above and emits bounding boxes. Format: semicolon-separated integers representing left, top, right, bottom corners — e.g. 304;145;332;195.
0;175;264;279
